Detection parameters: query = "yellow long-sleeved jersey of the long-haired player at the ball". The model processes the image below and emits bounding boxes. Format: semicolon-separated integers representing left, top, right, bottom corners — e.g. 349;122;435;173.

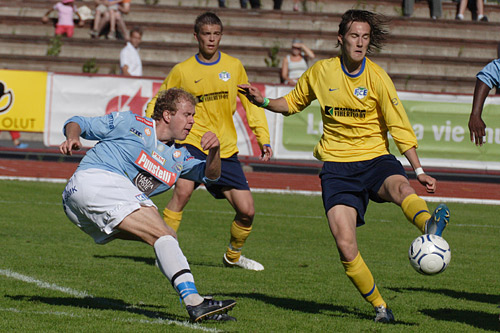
284;56;417;162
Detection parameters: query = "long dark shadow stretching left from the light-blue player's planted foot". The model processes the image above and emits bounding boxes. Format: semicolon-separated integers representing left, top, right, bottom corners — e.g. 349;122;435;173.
5;295;188;321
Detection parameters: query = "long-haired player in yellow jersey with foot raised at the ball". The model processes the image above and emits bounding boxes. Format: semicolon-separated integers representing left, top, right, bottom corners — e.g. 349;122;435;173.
240;10;450;322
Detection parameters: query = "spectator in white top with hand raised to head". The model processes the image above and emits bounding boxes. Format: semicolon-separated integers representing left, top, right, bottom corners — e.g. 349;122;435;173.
281;38;316;84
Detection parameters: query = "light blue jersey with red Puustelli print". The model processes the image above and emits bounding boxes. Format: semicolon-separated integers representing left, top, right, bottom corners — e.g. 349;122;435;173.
64;111;216;196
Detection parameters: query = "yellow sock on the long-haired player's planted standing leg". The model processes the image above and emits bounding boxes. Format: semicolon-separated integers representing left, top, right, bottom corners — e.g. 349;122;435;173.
342;252;387;307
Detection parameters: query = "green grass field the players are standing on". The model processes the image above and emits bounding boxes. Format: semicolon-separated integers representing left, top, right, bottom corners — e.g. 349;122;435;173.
0;181;500;332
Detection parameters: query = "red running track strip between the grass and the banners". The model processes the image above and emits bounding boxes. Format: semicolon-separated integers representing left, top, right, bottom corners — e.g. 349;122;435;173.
0;159;500;200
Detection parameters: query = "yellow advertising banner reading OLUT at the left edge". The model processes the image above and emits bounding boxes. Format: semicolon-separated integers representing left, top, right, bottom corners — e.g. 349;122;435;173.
0;69;47;132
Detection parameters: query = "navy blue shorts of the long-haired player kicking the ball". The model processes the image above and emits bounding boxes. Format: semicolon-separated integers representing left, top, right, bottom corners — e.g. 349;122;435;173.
319;155;408;226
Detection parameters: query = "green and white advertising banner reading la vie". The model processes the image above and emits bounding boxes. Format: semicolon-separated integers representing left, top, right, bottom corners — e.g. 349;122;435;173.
266;86;500;170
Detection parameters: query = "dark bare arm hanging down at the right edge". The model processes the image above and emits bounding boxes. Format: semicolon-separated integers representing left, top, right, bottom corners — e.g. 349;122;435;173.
469;79;490;146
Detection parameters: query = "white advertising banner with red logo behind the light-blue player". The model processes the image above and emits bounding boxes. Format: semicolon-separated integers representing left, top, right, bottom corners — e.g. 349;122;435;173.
44;73;264;156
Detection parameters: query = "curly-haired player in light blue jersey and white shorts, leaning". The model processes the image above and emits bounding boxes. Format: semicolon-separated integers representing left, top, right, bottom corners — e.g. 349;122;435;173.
59;89;236;322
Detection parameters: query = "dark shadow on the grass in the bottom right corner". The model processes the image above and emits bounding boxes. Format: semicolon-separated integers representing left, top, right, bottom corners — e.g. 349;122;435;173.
420;309;500;332
